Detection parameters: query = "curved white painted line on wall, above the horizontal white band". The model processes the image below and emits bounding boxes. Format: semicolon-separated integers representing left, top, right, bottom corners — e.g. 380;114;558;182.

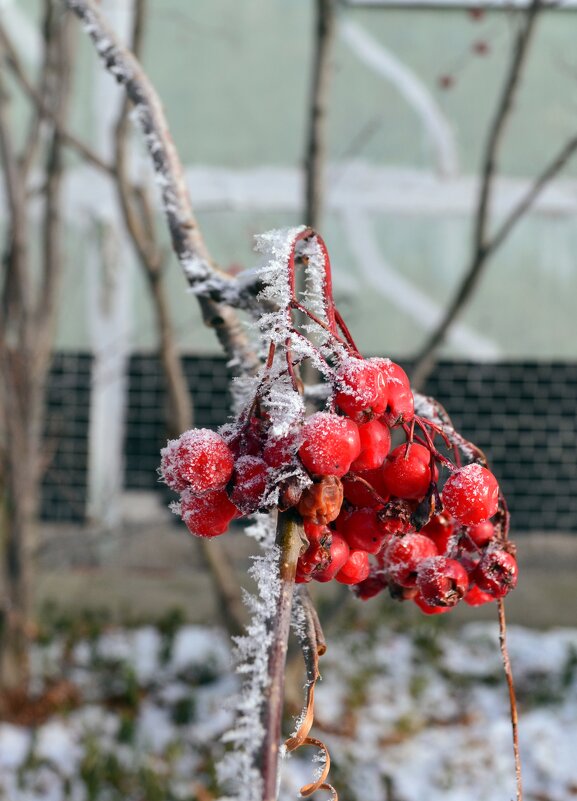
340;19;459;176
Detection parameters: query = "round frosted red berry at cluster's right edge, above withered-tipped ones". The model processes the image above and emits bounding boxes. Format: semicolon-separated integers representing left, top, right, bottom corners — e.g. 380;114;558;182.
442;464;499;526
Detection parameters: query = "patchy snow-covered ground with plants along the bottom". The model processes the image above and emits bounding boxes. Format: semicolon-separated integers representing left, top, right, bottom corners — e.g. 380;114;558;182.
0;622;577;801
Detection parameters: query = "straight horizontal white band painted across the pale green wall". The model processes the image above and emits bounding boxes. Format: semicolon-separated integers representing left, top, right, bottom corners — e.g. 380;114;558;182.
0;162;577;219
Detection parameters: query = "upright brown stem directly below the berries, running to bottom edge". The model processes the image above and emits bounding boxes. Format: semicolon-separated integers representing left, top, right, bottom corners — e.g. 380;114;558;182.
260;511;303;801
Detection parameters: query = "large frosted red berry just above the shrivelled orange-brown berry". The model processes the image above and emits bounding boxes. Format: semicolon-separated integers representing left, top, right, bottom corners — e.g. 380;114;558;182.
299;412;361;478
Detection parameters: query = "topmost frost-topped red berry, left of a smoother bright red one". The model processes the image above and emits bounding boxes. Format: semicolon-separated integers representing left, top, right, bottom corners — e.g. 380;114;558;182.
335;358;387;422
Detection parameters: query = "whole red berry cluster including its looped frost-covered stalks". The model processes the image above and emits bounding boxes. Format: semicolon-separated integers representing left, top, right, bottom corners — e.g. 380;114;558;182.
160;229;517;614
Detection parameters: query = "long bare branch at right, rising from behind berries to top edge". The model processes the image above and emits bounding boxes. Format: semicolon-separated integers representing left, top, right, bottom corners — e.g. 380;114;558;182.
411;0;542;389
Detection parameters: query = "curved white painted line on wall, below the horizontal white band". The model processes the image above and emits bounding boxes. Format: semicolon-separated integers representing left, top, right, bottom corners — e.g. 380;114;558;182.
341;209;500;360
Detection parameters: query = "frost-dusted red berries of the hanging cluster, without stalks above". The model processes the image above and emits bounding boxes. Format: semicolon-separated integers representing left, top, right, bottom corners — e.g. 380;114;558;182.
161;348;517;614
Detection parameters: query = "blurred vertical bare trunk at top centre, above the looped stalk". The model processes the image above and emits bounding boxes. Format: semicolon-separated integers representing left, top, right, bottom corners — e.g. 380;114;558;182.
304;0;336;229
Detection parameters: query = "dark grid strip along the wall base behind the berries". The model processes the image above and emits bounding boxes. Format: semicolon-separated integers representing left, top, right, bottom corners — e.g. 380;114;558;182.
42;354;577;531
